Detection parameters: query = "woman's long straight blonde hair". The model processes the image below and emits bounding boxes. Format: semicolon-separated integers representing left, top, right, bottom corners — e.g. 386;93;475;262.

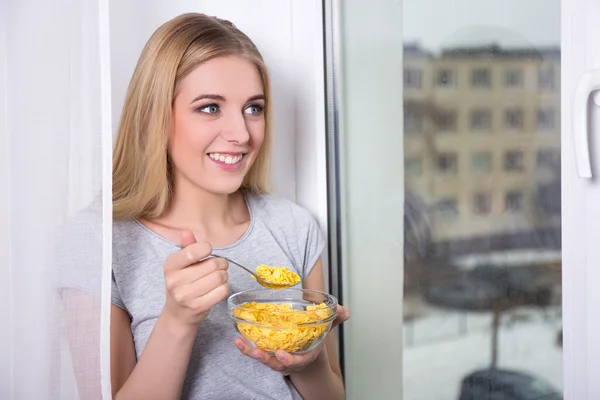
113;13;272;219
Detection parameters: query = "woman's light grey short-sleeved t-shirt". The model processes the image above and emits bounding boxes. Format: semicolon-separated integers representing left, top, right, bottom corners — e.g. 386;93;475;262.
112;194;324;400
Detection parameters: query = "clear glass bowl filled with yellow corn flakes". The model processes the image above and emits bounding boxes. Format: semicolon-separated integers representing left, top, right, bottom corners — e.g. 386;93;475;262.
227;288;338;355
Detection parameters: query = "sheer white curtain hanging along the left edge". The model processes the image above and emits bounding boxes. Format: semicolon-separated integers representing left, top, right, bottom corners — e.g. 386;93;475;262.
0;0;112;400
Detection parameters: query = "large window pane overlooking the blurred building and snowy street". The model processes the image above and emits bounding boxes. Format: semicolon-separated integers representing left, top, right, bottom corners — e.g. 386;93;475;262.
328;0;568;400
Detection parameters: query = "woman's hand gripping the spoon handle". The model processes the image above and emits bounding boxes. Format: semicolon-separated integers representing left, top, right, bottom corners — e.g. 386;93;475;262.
163;231;229;328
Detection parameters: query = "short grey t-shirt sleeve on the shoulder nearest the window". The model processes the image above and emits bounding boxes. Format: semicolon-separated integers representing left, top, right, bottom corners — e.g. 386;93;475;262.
294;206;325;280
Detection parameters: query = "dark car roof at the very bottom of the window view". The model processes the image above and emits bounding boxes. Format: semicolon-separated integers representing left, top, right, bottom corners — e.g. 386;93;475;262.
459;368;563;400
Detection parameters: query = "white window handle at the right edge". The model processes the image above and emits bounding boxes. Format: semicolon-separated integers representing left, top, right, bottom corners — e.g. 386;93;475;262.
572;69;600;178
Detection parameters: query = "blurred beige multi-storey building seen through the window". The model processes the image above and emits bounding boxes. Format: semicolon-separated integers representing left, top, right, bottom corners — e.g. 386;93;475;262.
404;44;560;256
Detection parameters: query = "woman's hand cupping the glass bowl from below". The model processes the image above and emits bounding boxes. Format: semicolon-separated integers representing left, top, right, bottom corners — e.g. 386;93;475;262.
234;306;350;376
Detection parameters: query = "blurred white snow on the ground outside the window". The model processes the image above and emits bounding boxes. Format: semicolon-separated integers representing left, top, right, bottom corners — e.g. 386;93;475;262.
403;308;562;400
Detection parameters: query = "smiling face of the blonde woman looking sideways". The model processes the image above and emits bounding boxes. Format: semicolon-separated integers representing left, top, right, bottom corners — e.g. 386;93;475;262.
169;56;265;194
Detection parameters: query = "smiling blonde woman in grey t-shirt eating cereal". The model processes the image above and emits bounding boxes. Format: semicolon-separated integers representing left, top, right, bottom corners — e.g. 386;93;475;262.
111;14;349;400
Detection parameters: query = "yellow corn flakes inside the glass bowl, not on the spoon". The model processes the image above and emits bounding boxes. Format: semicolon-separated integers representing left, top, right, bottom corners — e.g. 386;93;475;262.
233;302;330;353
